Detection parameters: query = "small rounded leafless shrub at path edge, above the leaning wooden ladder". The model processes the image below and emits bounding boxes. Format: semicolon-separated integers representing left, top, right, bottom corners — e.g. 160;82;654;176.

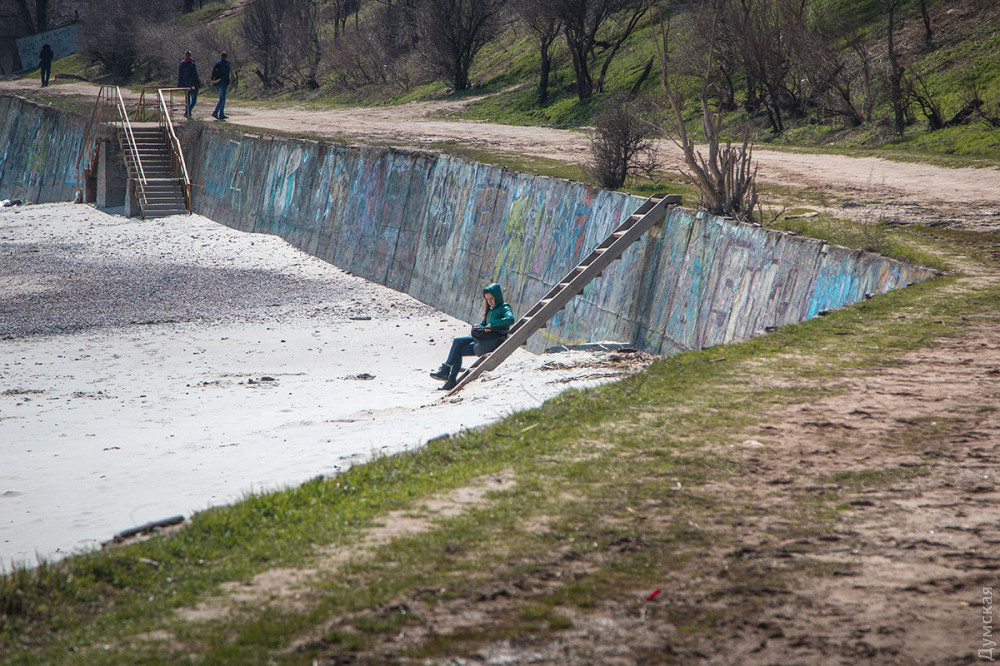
589;98;660;190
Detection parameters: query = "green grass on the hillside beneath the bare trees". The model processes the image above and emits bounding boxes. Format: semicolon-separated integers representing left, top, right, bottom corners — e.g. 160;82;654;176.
32;0;1000;167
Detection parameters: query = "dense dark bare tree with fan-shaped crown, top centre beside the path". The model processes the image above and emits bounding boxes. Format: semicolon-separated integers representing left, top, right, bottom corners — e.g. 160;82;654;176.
418;0;507;91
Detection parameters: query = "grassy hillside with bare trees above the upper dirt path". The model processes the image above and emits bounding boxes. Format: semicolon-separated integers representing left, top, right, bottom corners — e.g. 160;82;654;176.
68;0;1000;145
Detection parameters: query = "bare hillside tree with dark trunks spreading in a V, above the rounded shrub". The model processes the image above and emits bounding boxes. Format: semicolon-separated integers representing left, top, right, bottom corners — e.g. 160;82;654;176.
552;0;646;99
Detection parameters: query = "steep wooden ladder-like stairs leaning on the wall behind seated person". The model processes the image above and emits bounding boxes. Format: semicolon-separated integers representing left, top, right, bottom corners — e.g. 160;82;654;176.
448;189;681;395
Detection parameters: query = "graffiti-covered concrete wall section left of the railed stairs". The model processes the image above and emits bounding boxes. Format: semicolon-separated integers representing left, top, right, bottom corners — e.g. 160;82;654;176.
0;97;87;203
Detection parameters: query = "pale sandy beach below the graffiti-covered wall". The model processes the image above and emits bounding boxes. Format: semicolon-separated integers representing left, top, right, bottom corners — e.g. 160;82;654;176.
0;204;632;565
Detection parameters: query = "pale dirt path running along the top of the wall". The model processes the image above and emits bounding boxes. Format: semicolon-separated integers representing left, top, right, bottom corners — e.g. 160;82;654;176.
0;81;1000;230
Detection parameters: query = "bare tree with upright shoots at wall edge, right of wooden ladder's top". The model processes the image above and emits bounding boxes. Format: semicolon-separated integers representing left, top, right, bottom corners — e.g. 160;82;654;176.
650;0;757;220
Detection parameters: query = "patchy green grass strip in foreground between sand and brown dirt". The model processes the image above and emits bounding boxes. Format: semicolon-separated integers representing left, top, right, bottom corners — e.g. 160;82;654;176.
0;220;1000;664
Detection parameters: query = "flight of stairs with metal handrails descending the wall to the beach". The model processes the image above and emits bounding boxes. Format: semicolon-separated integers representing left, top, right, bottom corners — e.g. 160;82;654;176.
120;123;188;218
